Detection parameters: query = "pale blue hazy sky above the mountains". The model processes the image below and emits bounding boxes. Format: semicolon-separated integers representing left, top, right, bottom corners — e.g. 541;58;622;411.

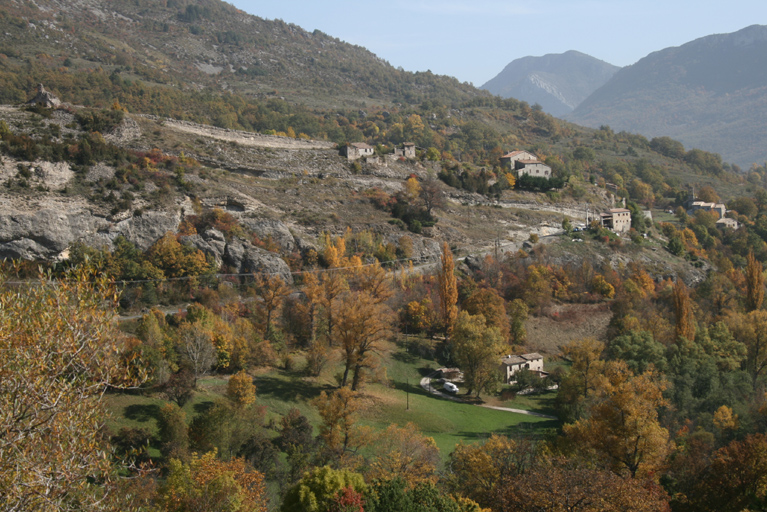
227;0;767;86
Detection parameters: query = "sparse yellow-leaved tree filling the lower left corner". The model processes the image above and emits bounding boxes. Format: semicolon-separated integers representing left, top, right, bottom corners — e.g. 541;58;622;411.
0;269;146;511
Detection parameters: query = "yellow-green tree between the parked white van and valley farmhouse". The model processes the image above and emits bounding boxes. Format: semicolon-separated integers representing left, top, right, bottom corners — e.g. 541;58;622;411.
450;311;503;397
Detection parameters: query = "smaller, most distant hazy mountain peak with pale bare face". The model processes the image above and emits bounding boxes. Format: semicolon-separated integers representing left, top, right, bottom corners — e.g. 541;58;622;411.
481;50;620;116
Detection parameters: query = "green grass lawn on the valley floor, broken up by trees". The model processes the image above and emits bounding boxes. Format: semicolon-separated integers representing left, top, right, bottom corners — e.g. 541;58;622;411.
106;338;559;459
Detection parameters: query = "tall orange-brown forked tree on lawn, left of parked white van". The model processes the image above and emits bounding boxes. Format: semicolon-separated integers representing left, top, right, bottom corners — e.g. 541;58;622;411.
337;292;391;391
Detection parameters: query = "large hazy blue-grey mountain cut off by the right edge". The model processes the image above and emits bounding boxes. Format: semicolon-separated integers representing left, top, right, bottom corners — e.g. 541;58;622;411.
567;25;767;167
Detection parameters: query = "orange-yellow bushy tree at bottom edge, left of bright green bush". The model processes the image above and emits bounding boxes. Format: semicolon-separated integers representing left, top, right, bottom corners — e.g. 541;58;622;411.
158;452;267;512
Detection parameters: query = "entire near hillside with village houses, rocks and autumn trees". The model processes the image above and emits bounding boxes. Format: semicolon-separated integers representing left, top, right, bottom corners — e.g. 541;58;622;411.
0;0;767;512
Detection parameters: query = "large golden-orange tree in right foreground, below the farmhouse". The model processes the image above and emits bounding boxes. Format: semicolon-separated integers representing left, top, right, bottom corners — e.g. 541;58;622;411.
564;361;671;477
